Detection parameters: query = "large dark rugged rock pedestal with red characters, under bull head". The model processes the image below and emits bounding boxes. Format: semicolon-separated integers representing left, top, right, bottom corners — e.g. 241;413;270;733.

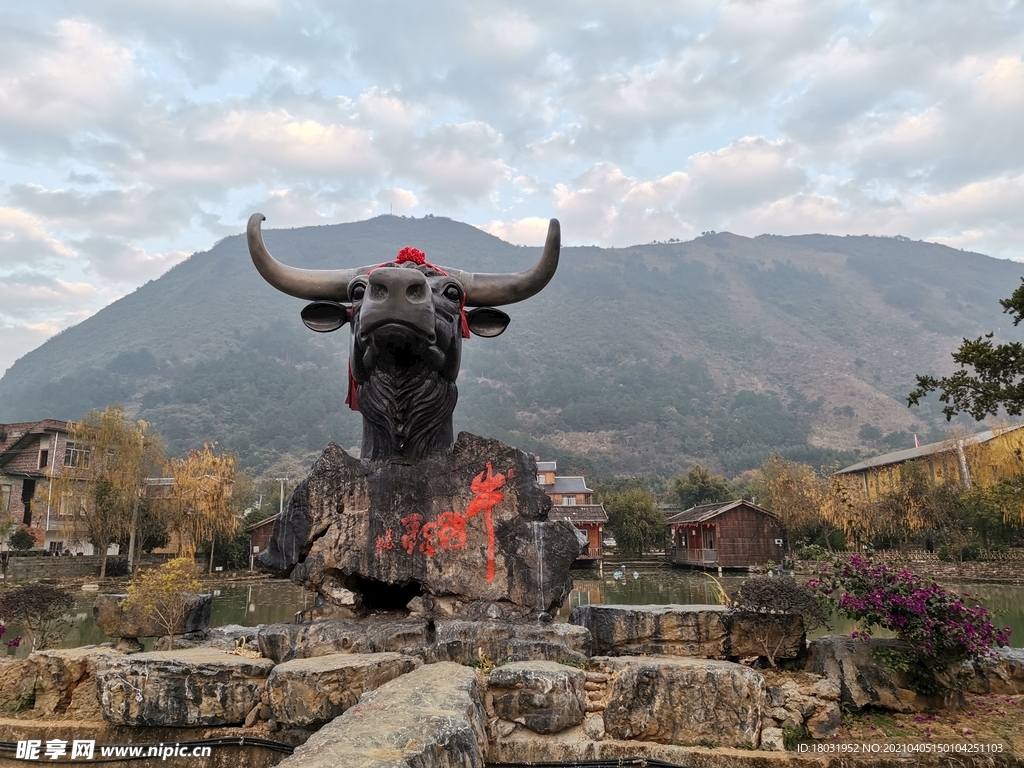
259;432;585;620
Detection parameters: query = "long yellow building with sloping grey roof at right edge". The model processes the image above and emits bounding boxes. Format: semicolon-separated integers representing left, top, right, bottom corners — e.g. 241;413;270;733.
835;425;1024;502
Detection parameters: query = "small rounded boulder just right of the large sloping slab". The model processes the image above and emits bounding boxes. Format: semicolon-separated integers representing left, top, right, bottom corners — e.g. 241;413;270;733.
487;662;587;733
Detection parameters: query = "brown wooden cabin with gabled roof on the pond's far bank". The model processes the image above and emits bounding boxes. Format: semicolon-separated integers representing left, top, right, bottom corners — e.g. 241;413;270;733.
668;500;785;568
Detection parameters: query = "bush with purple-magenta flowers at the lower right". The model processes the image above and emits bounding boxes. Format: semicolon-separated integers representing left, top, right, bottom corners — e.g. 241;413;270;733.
807;555;1010;693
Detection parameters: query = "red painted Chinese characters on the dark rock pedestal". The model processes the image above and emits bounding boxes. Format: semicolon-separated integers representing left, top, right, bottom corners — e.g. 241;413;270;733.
377;462;512;582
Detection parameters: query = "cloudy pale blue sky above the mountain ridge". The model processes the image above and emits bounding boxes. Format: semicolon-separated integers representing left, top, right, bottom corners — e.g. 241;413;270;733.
0;0;1024;371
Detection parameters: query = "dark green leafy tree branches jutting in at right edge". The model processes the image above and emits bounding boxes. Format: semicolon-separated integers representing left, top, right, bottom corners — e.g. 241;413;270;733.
907;279;1024;421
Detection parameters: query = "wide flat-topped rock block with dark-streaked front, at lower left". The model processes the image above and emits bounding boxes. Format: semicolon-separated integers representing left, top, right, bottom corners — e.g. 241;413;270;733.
96;648;273;727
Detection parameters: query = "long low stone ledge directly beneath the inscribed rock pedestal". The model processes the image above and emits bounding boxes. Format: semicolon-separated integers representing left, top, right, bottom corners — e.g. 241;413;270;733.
256;616;590;664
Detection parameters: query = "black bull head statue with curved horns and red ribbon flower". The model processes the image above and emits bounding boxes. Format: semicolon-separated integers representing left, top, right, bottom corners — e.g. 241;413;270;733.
246;213;561;461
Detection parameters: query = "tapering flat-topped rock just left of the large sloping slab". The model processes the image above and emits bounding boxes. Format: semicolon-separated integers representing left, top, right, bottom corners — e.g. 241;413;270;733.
266;653;423;726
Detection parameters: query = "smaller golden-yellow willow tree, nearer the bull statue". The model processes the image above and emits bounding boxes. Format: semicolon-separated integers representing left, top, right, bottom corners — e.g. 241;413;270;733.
167;444;238;563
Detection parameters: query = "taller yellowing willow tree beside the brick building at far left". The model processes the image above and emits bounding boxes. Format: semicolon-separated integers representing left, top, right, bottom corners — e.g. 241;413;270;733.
49;406;160;578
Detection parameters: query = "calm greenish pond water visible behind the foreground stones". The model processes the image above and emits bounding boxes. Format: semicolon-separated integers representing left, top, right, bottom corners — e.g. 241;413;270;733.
14;569;1024;656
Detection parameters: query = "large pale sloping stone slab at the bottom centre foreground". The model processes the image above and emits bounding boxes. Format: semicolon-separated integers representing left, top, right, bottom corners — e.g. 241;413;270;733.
279;663;487;768
